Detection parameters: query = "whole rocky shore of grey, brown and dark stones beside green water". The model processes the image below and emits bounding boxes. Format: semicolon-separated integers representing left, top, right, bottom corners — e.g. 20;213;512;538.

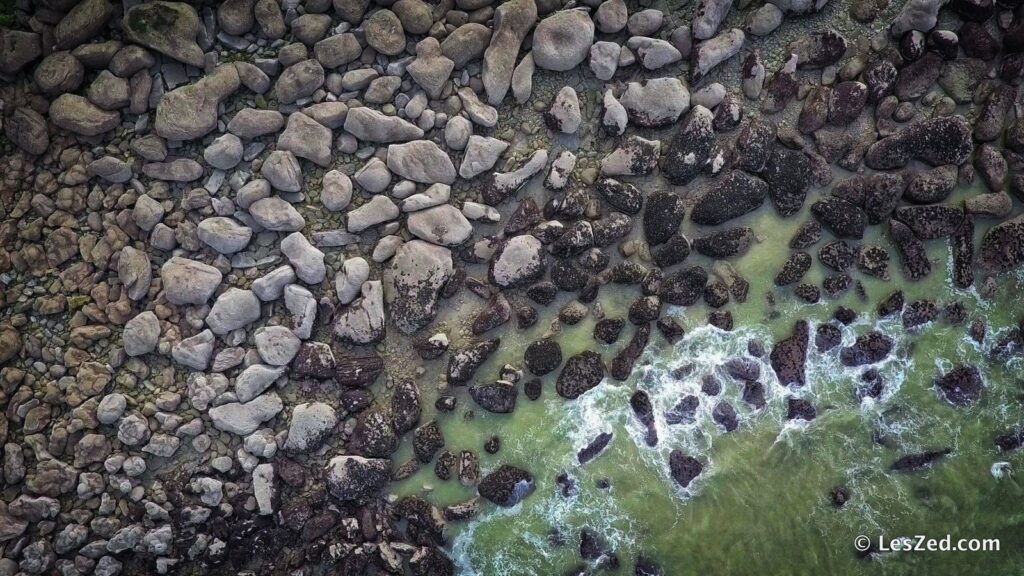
0;0;1024;576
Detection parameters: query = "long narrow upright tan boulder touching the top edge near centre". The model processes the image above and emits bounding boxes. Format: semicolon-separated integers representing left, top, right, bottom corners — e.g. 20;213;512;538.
481;0;540;106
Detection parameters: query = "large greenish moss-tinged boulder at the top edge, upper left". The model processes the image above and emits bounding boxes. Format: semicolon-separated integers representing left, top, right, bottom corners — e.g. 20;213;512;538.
121;0;203;68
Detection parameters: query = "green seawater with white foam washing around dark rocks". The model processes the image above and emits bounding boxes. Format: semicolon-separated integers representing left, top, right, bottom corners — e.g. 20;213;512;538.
387;172;1024;576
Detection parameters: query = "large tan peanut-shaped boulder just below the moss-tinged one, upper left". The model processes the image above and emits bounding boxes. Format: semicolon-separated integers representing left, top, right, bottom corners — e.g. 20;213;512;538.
154;64;241;140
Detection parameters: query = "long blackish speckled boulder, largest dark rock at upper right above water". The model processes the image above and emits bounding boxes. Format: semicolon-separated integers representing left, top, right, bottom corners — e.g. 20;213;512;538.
864;116;974;170
